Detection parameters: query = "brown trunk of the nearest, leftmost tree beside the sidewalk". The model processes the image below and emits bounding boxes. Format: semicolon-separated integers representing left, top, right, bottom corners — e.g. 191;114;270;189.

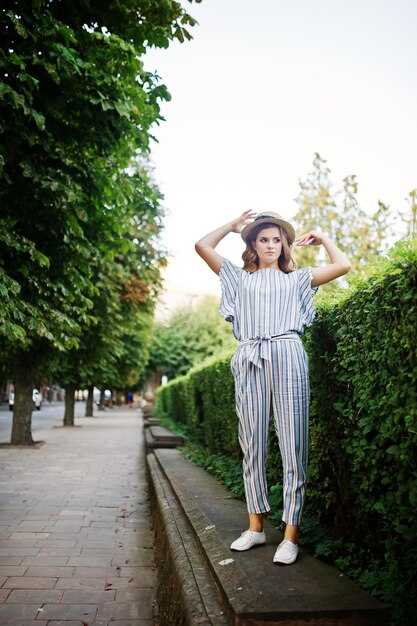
10;363;34;446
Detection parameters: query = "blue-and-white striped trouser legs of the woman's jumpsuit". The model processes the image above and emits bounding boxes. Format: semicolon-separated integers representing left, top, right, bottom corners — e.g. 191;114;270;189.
232;338;310;525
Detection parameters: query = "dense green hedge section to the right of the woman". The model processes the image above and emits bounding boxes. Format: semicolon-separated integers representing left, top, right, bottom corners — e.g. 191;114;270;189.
302;244;417;615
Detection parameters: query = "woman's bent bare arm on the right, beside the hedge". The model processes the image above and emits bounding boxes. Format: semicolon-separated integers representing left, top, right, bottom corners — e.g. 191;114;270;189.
296;230;352;287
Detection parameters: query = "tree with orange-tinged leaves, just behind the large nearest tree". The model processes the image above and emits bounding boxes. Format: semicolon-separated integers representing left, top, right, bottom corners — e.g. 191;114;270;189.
54;162;166;426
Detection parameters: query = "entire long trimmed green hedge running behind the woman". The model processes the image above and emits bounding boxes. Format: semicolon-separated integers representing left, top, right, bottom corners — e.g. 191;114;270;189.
157;244;417;624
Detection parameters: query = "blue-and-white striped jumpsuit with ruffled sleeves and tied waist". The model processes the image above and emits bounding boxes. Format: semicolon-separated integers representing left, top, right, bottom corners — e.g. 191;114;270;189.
220;259;317;525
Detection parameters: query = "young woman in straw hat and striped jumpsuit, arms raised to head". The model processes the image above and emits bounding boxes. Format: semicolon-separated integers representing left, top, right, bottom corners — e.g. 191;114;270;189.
195;211;350;565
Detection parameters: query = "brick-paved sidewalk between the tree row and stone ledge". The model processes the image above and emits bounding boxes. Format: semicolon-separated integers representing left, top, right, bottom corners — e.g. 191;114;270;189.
0;408;155;626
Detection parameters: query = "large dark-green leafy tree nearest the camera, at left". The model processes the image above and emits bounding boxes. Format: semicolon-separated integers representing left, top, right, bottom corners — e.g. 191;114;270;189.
0;0;202;444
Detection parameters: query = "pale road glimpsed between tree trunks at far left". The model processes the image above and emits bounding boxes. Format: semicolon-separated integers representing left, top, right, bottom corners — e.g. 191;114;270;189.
0;402;91;443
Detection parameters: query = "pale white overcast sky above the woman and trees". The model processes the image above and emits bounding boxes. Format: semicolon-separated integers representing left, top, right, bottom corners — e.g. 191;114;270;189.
145;0;417;308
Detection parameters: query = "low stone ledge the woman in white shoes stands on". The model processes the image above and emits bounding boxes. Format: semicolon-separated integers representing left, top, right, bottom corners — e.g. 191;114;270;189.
147;449;387;626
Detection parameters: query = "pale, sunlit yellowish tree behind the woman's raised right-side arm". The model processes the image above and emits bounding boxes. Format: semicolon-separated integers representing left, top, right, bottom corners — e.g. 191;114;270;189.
294;153;392;278
